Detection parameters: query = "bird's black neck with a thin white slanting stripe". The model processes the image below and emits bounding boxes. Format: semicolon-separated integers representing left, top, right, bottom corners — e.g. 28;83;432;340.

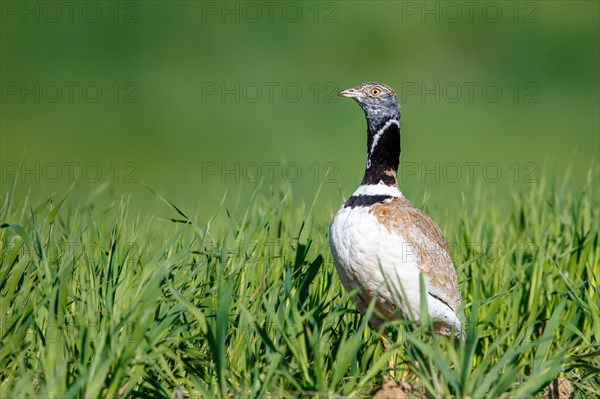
361;118;400;186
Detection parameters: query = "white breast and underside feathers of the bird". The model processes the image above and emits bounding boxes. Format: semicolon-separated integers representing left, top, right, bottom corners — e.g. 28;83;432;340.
330;203;460;332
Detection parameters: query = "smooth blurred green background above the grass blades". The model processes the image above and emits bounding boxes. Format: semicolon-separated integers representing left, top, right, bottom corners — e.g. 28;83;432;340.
0;1;600;217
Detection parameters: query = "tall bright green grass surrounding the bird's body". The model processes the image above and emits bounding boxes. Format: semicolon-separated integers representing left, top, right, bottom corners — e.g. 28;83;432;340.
0;165;600;398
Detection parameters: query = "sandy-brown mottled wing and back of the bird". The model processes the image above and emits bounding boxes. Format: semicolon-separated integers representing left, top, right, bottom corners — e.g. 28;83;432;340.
370;197;461;312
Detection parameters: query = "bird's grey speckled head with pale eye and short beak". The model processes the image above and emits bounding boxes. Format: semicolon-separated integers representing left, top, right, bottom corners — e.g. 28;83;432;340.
338;82;400;122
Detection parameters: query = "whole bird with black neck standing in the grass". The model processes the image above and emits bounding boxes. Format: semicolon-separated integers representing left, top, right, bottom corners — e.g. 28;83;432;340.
329;82;462;340
